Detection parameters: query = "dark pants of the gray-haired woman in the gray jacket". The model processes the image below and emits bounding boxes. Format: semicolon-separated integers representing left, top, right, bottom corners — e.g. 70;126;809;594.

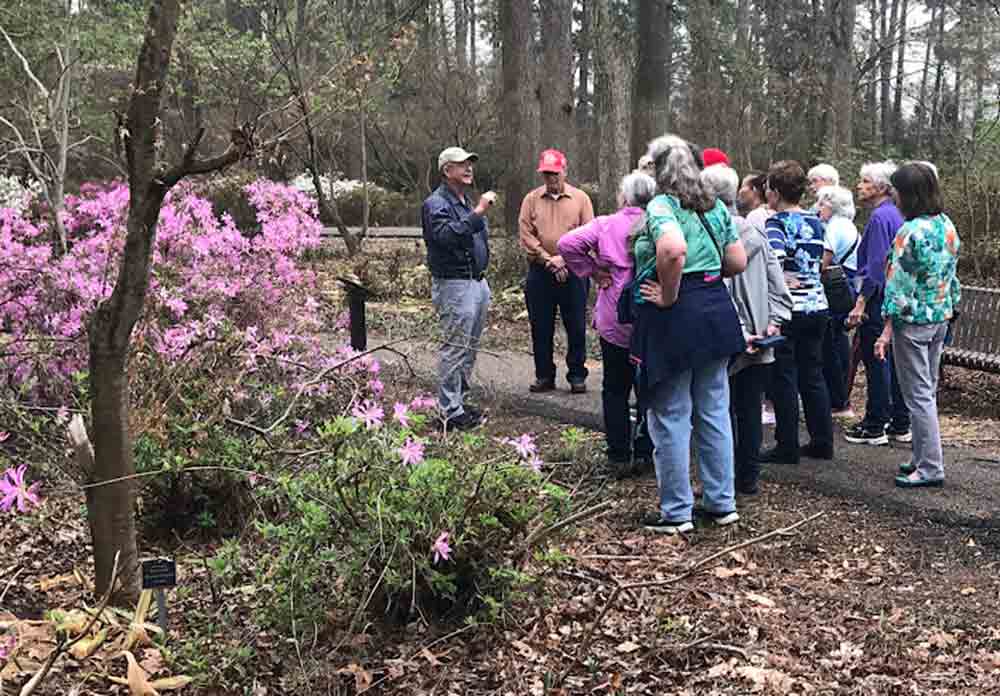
729;365;768;491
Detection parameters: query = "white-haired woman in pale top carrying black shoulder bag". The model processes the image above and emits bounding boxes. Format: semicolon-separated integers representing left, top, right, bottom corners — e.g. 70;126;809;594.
816;186;861;418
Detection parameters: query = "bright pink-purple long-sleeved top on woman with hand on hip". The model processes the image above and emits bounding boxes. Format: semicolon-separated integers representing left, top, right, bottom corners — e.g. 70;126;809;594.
558;208;643;348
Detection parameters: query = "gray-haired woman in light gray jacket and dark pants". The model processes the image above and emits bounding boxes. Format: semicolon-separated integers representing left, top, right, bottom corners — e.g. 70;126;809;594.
701;165;792;495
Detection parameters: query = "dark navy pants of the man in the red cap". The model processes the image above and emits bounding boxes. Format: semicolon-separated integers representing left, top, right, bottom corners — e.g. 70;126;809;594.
524;263;590;382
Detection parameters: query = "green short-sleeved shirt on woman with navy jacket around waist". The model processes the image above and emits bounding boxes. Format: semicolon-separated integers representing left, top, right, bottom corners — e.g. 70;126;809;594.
632;194;739;302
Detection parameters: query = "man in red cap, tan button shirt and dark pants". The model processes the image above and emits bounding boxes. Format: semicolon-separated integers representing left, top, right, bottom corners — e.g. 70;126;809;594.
518;150;594;394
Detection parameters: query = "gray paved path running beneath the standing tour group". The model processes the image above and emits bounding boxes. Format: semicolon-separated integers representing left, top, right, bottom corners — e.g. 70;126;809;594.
386;343;1000;528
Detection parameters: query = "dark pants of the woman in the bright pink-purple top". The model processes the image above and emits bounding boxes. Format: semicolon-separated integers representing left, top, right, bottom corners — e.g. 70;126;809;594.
601;338;652;462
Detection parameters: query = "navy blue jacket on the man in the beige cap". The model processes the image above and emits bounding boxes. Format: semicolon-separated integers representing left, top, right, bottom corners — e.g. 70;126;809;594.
420;184;490;278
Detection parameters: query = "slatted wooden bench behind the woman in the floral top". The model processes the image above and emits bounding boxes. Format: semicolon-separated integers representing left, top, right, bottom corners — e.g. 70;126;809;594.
941;287;1000;373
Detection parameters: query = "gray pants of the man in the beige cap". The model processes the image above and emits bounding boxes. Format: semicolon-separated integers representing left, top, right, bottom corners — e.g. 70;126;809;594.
431;278;490;418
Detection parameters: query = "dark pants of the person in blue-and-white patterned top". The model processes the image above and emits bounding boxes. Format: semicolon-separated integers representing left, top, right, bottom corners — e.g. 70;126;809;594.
771;312;833;454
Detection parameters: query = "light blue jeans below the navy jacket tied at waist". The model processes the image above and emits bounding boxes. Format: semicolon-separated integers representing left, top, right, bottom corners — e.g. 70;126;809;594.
646;358;736;522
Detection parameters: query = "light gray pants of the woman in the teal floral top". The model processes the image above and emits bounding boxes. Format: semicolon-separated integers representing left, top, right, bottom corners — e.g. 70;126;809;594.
892;321;948;481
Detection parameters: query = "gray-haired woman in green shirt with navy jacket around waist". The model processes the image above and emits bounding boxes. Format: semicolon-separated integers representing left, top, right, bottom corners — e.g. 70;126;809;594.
632;135;746;534
